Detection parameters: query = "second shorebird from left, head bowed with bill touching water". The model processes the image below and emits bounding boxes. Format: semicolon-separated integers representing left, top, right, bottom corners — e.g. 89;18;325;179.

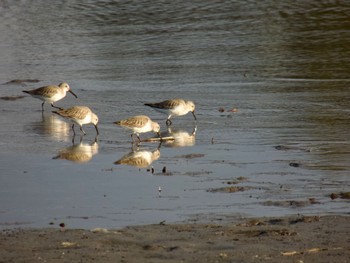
53;106;99;135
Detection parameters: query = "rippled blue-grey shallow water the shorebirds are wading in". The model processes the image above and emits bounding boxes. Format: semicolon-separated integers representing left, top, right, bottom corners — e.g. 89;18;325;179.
0;1;350;228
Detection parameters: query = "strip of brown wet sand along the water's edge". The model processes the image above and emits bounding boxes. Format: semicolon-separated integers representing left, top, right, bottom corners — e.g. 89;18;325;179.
0;216;350;263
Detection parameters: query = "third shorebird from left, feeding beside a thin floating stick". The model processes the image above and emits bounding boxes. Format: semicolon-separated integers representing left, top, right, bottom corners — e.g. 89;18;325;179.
114;115;160;142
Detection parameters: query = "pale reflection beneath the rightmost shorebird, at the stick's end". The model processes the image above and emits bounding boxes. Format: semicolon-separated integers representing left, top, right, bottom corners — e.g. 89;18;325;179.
161;126;197;147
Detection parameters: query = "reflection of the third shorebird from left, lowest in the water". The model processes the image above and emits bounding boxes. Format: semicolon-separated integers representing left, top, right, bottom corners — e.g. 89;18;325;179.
114;147;160;168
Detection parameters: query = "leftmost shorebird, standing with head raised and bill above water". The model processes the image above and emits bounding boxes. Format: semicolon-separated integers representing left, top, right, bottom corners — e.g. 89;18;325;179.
23;82;78;111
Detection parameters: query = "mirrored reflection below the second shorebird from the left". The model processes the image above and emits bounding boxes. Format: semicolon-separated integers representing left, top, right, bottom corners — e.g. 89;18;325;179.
52;136;98;163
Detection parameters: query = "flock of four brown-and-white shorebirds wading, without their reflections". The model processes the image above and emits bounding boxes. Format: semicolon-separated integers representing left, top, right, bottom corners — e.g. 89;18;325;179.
23;82;197;142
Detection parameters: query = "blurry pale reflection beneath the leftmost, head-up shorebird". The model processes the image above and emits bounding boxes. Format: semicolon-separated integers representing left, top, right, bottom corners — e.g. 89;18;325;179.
30;113;71;141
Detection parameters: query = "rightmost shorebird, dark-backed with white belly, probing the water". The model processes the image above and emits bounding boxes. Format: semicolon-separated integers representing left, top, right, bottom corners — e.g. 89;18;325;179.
145;99;197;126
